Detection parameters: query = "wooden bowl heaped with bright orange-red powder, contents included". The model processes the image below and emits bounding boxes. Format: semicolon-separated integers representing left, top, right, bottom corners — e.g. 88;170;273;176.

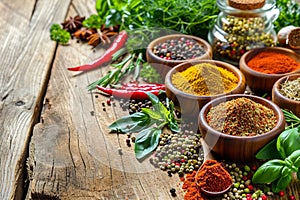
239;47;300;94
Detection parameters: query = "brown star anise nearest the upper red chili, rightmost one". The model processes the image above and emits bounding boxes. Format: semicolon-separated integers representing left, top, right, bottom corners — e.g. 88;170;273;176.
87;25;119;47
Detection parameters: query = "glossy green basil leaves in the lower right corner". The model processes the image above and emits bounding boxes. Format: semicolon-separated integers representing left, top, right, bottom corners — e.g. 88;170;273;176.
252;126;300;192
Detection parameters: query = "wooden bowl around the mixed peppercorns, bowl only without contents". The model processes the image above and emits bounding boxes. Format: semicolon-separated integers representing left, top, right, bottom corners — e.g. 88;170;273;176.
146;34;212;79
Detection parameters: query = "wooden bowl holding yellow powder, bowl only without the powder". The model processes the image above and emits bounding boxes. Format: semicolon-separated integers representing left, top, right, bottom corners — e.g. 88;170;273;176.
165;60;246;123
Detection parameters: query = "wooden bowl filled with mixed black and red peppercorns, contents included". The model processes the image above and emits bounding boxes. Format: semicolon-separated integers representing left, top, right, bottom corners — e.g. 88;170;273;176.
146;34;212;78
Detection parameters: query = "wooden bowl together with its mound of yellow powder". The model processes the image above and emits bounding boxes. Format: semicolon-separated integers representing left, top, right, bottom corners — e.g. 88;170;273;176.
165;60;246;122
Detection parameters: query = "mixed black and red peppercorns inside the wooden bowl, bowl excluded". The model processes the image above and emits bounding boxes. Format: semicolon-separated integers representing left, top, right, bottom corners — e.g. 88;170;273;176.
153;37;205;60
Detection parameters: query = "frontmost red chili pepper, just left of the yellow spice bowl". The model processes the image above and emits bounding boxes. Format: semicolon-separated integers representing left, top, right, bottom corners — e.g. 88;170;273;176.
97;85;160;100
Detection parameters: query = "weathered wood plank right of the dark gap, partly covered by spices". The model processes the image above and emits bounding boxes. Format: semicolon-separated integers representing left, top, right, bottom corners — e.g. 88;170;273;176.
28;0;182;199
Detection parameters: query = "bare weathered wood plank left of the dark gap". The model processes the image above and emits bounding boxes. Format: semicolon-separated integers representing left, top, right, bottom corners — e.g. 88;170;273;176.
0;0;70;199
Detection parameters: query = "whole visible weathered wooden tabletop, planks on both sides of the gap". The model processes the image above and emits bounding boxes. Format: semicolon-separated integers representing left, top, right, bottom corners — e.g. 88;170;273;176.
0;0;298;200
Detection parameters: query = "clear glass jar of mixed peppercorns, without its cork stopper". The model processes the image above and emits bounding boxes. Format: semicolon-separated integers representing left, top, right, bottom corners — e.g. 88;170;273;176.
208;0;279;66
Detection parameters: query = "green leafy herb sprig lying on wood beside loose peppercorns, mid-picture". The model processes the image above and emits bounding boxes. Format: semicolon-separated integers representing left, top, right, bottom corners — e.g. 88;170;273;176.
109;92;179;159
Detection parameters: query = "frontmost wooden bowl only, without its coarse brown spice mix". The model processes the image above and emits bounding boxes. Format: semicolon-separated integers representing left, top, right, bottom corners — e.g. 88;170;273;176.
199;94;285;162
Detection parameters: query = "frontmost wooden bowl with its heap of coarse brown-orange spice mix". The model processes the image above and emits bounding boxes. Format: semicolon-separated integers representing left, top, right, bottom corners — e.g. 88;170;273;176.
199;94;285;162
